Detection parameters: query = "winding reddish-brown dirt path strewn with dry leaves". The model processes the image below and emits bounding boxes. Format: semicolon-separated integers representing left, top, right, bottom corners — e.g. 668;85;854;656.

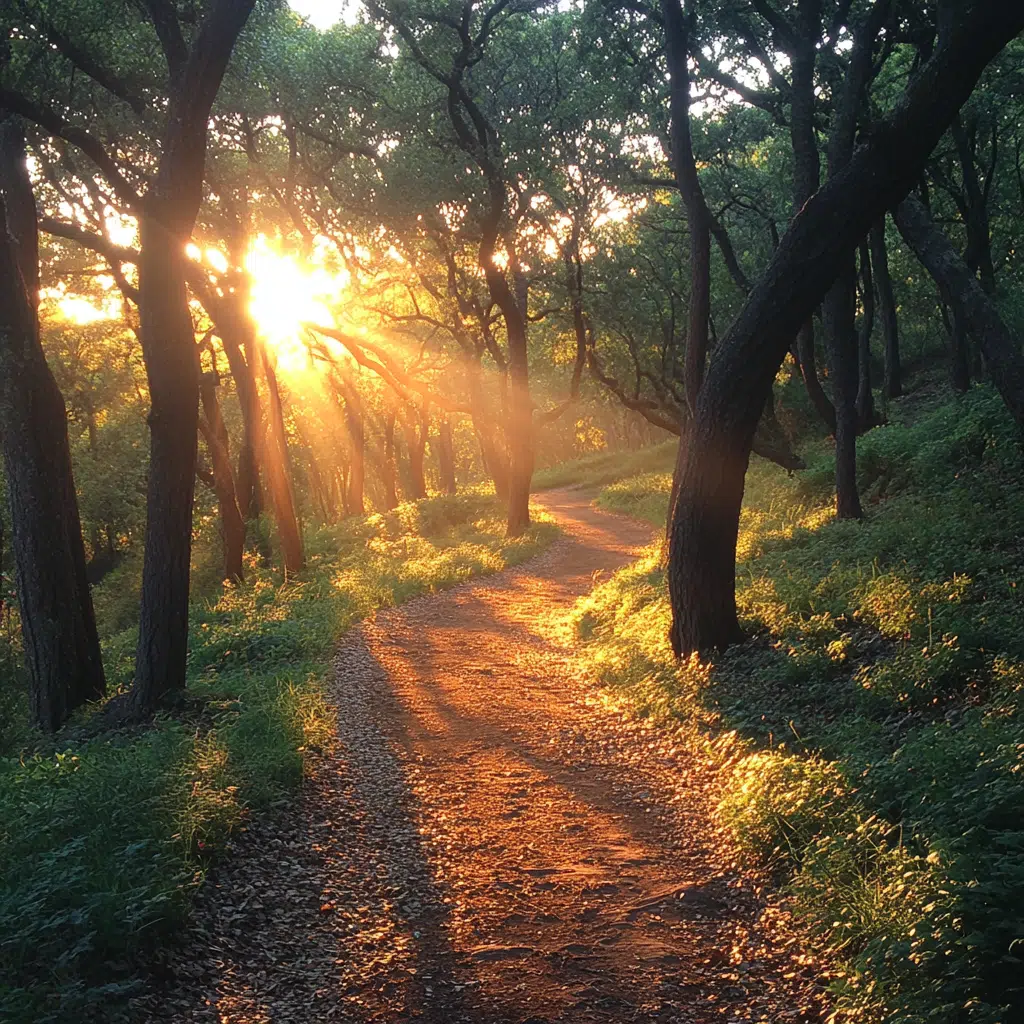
135;492;818;1024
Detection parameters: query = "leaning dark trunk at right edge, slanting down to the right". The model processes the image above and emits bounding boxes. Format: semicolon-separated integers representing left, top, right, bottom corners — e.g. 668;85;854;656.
894;197;1024;429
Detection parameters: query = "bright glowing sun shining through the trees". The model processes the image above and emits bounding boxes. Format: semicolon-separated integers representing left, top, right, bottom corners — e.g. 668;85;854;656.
246;234;350;374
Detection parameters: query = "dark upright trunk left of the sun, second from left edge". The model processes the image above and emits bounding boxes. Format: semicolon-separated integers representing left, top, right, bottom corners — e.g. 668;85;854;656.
129;0;254;717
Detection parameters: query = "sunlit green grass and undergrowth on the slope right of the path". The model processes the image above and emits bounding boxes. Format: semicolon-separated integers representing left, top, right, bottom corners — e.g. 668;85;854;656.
574;387;1024;1024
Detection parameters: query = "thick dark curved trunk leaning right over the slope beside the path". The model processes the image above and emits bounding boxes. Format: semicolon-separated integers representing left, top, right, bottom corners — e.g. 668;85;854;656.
669;0;1024;655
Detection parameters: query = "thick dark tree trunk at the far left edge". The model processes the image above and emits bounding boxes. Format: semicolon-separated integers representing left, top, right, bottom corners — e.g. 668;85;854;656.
0;121;106;732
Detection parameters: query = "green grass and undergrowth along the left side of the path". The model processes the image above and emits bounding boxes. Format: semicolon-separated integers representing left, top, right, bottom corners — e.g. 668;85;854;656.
0;495;556;1022
